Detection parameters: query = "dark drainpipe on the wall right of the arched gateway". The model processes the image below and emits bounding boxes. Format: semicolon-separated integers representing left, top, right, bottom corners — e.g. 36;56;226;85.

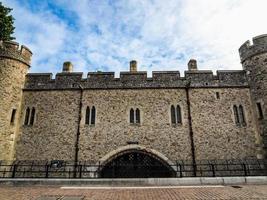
185;82;197;176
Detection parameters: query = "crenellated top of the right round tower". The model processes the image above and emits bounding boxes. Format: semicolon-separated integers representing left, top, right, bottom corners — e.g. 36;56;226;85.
239;34;267;63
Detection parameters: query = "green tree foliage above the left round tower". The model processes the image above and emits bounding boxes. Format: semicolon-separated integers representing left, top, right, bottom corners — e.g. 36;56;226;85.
0;2;16;41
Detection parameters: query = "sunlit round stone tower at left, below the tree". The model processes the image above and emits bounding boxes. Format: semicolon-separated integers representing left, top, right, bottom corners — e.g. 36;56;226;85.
0;41;32;160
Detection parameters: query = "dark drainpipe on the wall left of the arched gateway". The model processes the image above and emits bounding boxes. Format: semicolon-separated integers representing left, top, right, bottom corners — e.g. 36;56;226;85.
73;83;83;178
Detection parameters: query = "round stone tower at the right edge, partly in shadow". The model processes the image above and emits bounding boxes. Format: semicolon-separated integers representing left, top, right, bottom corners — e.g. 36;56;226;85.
239;34;267;158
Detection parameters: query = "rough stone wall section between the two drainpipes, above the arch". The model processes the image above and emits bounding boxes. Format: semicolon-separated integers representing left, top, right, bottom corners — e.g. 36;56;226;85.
79;89;194;162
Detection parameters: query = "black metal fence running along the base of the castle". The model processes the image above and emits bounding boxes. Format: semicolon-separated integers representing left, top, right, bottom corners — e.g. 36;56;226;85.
0;159;267;179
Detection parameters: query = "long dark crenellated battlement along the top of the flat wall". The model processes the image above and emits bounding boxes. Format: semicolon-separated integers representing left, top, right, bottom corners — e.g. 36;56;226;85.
24;70;248;90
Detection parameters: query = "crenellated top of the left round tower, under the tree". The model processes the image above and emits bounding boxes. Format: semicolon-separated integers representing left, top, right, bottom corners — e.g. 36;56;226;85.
0;41;32;66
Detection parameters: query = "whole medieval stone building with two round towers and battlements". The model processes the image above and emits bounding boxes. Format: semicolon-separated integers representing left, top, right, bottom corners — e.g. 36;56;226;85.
0;35;267;177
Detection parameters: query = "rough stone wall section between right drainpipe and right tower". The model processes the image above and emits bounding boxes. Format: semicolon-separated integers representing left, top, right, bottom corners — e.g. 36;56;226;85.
192;88;257;160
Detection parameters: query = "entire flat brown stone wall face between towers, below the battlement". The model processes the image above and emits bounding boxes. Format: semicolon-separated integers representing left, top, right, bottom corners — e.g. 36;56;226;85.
16;88;256;163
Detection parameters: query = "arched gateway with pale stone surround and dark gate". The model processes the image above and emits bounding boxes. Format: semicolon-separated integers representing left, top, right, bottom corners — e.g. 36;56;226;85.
99;145;175;178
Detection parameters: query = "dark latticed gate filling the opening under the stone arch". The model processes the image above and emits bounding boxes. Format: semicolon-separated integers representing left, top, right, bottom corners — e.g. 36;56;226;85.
100;151;175;178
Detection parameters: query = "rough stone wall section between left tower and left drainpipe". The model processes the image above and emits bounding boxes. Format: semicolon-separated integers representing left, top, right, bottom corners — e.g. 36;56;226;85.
16;91;79;160
